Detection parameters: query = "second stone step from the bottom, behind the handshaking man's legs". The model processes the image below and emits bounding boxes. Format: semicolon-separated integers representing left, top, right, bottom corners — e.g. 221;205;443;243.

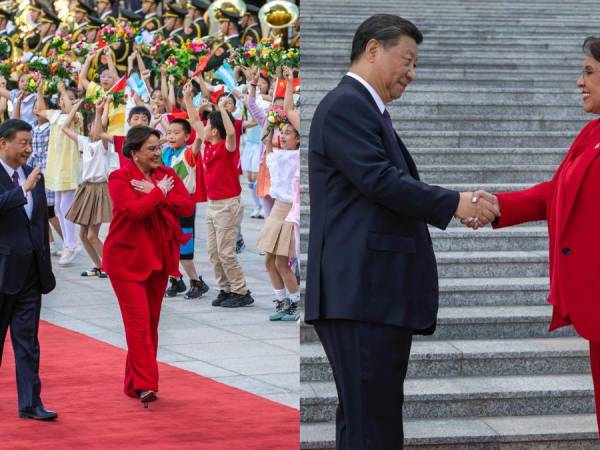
300;374;594;422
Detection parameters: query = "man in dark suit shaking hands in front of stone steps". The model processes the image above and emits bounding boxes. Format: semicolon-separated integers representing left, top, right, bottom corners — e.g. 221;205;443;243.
305;14;498;450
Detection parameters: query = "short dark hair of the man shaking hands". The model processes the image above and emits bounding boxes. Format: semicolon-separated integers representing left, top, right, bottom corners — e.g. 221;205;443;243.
350;14;423;63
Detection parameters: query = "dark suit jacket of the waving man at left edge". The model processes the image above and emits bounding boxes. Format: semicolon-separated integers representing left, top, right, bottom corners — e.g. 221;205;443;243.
0;165;56;294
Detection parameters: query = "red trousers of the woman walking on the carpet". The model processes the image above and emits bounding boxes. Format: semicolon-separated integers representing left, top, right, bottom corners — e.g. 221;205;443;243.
110;272;169;397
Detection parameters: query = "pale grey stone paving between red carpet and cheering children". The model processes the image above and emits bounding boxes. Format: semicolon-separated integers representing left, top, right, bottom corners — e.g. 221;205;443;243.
42;188;299;408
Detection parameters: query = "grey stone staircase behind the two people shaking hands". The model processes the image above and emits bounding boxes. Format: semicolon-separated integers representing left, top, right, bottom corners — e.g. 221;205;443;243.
300;0;600;450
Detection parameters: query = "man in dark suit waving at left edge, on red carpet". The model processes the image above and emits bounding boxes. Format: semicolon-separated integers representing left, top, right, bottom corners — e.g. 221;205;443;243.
0;119;57;420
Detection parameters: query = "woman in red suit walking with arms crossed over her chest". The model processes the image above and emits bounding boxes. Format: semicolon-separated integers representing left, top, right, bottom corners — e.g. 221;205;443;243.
103;126;194;407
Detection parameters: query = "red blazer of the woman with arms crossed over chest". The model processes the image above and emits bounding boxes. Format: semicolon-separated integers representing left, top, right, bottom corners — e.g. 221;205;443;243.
102;161;195;281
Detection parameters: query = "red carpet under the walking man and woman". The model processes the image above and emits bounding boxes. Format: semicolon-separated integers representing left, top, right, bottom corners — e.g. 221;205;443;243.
0;322;299;450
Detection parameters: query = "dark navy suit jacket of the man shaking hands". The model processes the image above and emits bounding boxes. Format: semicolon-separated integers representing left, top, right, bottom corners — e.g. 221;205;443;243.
305;76;459;334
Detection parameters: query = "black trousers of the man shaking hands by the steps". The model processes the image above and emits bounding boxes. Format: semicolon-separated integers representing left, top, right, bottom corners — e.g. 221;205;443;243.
314;320;412;450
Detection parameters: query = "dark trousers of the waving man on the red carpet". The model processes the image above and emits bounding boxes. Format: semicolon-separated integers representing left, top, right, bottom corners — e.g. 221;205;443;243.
0;255;42;410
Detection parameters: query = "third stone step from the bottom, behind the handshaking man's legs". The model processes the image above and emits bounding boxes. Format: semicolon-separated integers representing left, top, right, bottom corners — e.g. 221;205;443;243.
300;337;590;382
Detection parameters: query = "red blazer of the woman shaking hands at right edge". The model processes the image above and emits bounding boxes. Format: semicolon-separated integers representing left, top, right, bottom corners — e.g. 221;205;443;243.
494;120;600;342
